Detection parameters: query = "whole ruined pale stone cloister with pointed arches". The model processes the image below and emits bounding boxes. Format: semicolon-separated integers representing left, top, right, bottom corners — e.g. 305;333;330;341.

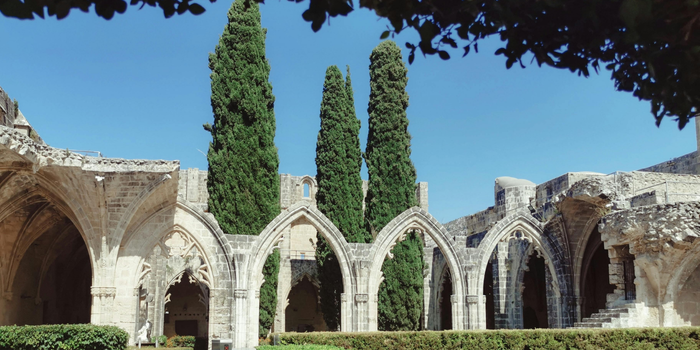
0;90;700;348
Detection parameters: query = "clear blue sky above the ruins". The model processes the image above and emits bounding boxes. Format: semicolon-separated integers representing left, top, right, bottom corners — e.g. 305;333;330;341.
0;0;696;222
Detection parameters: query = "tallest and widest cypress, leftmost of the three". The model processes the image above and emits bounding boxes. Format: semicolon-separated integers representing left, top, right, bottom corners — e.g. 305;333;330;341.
204;0;280;335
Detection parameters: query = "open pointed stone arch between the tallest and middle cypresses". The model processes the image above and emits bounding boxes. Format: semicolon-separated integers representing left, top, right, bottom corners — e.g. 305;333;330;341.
245;202;357;346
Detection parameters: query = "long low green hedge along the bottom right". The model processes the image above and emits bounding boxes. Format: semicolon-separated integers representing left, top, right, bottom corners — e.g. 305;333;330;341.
280;327;700;350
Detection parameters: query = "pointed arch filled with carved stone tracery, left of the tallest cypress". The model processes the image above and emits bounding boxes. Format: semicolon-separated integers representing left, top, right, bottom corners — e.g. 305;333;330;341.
115;201;236;342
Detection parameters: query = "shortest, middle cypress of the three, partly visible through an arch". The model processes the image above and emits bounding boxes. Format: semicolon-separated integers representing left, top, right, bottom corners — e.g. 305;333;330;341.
316;66;367;330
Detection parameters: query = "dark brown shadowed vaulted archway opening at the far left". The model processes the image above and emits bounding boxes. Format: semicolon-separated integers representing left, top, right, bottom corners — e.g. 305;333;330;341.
0;168;93;325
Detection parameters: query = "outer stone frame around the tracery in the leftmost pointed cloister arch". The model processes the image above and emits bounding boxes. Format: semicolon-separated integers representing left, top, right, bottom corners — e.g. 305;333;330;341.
115;199;236;339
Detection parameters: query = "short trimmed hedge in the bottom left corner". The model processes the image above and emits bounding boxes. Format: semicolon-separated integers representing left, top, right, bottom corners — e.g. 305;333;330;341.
0;324;129;350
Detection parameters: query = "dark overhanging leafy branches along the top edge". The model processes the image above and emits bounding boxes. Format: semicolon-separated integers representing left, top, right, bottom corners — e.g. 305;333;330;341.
6;0;700;128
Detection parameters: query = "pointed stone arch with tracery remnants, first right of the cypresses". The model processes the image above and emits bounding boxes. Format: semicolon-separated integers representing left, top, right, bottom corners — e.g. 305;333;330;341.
474;209;568;328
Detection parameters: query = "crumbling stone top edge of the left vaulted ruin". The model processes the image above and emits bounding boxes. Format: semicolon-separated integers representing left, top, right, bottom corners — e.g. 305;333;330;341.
0;126;180;173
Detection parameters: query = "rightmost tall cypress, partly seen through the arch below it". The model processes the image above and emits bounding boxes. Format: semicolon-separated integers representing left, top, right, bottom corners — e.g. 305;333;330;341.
365;40;423;330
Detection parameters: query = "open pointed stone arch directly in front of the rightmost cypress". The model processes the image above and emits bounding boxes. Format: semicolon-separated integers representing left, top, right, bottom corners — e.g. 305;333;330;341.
368;207;467;330
